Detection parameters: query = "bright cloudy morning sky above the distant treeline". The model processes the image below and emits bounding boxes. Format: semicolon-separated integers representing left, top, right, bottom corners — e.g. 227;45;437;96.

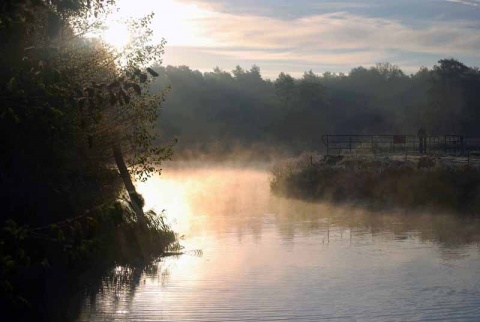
108;0;480;79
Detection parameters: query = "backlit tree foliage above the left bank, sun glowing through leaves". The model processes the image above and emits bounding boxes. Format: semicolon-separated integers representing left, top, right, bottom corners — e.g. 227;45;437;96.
0;0;173;224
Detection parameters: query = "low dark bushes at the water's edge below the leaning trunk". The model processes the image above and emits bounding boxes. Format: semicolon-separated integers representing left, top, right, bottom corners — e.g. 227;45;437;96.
0;199;177;319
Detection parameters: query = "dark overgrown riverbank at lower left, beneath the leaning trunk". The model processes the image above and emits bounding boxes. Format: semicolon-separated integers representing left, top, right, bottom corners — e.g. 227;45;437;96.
1;198;178;321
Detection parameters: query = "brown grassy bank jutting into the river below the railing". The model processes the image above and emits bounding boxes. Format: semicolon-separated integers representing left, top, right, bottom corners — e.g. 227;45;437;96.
270;154;480;213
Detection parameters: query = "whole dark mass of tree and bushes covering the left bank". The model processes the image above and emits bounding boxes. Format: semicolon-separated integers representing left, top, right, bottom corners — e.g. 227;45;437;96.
0;0;175;320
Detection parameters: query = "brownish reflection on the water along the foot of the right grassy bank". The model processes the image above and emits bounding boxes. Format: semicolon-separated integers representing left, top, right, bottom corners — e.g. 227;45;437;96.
272;199;480;249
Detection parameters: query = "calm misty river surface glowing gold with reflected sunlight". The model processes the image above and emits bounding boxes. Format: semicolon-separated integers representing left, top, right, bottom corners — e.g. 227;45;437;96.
78;164;480;321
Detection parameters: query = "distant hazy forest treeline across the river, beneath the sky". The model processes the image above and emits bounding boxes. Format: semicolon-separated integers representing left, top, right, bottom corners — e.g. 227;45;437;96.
152;59;480;152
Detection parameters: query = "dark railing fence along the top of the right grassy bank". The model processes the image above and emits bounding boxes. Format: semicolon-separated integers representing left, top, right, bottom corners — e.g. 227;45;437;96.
322;135;480;155
